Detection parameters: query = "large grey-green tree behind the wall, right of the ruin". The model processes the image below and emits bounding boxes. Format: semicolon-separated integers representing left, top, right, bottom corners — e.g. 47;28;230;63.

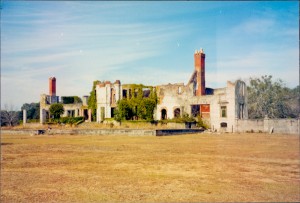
248;75;291;119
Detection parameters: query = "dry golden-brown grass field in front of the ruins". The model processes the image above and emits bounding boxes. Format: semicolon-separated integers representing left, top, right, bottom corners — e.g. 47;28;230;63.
1;134;300;202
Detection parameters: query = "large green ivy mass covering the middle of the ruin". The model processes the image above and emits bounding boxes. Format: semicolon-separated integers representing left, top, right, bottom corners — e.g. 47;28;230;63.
114;84;157;121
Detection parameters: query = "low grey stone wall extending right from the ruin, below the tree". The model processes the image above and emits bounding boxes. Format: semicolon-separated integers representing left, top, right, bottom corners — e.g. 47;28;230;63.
235;118;300;134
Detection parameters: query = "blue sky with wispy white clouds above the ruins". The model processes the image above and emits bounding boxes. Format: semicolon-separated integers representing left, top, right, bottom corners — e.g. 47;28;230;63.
1;0;299;110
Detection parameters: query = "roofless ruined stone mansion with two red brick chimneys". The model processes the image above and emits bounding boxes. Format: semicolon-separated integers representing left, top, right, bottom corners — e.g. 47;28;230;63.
40;49;248;132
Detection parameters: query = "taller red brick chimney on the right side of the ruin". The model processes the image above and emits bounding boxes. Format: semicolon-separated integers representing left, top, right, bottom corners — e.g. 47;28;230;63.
194;49;205;96
